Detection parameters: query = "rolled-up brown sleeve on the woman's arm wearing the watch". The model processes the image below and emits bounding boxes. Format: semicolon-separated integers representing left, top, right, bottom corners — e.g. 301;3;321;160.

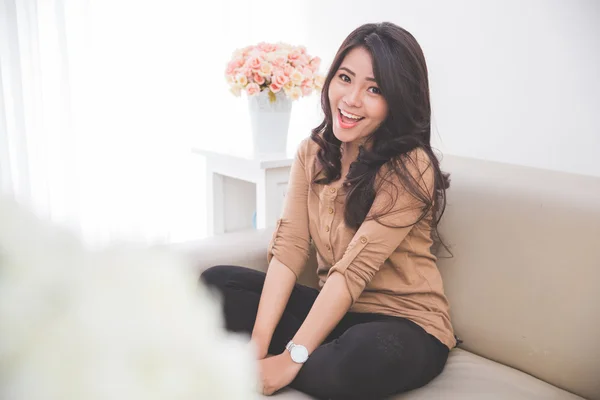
328;150;434;304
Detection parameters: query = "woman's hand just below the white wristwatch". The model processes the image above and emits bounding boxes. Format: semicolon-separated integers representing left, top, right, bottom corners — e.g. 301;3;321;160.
258;351;302;396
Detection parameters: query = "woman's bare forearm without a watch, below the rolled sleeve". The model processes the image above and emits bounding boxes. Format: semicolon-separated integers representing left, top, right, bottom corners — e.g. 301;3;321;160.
252;257;296;359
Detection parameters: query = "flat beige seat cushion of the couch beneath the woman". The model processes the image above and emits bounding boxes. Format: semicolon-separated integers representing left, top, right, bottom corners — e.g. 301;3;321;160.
263;349;582;400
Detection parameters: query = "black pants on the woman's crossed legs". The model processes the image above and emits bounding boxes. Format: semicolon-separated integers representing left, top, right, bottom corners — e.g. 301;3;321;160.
201;265;448;400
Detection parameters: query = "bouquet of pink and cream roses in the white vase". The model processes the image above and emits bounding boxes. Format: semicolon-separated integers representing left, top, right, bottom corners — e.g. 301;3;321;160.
225;42;325;101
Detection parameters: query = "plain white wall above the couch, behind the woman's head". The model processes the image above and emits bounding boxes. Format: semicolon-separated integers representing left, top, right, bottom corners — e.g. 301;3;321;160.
307;0;600;176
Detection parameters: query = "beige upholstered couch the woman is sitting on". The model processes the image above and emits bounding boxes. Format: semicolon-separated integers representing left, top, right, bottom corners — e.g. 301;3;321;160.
182;156;600;400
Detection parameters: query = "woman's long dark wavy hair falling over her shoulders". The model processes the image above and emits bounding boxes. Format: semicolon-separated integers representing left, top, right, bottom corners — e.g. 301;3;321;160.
311;22;449;247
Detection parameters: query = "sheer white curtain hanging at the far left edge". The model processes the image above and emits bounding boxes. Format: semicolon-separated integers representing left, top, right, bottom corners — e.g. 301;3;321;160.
0;0;81;222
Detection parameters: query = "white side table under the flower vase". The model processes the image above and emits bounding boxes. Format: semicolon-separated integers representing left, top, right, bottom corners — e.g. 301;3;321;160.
193;148;293;235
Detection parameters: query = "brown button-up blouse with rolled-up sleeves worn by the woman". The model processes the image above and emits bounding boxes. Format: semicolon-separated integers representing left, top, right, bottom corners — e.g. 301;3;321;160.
268;138;456;348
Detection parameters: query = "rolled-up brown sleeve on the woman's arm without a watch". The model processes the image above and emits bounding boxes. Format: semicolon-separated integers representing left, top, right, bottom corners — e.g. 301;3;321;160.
267;138;311;279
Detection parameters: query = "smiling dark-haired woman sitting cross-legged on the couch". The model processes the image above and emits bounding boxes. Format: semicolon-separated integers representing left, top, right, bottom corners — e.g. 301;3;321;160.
202;23;456;400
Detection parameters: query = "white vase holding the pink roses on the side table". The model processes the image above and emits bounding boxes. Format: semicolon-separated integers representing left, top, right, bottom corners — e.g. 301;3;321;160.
248;90;292;156
